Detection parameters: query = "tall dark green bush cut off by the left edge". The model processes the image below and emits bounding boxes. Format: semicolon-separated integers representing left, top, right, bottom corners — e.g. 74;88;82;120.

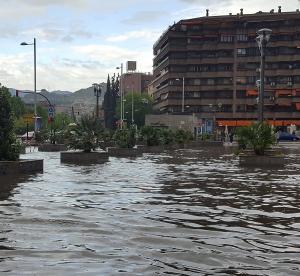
0;84;21;161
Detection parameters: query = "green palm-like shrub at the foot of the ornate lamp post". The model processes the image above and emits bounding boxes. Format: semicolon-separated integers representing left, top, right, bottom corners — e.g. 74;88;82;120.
237;123;276;155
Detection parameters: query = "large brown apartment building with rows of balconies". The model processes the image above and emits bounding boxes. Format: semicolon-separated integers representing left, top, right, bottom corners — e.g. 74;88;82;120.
151;7;300;126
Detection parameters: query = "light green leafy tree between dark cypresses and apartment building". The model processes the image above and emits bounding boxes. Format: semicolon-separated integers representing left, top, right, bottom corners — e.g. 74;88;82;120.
117;93;153;127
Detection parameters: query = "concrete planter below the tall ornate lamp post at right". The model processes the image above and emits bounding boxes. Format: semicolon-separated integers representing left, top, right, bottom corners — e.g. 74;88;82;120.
239;153;285;167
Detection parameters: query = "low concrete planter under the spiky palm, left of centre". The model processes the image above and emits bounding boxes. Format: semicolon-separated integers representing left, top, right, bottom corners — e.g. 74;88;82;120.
60;151;109;164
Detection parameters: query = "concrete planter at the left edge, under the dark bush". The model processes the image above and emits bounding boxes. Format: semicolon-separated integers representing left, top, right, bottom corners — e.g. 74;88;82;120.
0;159;44;175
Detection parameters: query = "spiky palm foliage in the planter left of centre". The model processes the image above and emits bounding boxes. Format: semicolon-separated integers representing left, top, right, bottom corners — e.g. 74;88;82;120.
67;116;104;152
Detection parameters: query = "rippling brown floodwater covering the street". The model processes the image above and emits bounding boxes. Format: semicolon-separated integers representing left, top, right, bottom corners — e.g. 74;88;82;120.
0;149;300;275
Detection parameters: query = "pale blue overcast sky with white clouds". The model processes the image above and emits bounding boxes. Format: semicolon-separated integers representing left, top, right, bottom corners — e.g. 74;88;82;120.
0;0;300;91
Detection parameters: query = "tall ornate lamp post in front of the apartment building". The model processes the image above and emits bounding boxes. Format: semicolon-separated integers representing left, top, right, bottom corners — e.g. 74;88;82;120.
256;29;272;122
